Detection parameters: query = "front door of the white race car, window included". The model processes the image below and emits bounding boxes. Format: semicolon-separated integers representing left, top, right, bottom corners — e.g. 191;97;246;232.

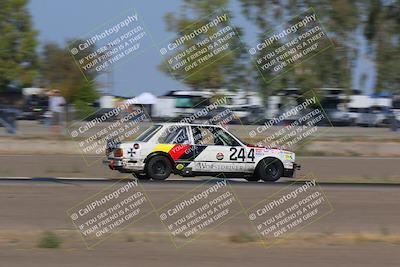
191;126;251;173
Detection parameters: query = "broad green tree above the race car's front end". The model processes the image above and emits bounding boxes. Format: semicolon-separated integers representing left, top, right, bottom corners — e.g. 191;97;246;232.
240;0;358;98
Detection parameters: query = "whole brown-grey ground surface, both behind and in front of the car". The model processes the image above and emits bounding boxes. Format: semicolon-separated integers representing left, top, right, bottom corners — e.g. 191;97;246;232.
0;155;400;267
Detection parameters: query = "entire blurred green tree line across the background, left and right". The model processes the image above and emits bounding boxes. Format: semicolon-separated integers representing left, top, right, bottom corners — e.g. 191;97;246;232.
0;0;400;113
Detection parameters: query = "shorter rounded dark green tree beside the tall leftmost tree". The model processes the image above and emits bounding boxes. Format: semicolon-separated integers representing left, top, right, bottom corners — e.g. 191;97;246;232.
41;40;98;118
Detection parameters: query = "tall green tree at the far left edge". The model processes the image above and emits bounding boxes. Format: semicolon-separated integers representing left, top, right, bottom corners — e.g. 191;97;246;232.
0;0;38;92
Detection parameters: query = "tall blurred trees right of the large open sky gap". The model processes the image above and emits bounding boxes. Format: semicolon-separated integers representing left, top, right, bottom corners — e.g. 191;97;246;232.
161;0;400;95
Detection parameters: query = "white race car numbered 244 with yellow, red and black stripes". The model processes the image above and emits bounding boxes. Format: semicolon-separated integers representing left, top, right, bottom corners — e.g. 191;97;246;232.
105;123;300;181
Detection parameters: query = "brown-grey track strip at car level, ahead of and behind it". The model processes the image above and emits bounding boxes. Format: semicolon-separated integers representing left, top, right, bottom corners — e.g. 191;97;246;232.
0;155;400;183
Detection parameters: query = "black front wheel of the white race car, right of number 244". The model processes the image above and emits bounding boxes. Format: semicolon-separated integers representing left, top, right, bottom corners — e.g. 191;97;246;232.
254;158;283;182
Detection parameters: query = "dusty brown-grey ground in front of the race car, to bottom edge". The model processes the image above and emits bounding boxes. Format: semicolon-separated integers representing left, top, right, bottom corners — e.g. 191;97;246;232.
0;180;400;266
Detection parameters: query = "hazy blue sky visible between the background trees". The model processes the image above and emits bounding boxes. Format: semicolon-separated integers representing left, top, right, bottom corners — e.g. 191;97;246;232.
29;0;376;96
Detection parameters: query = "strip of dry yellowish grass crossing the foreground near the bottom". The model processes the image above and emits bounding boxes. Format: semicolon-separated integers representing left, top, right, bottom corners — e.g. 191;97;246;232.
0;229;400;249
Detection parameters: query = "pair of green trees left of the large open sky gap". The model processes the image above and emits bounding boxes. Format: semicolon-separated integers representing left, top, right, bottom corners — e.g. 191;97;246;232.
0;0;98;119
